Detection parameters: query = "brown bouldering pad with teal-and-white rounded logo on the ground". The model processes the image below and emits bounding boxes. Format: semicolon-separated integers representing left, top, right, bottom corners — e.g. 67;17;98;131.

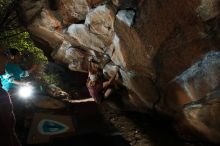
27;113;75;144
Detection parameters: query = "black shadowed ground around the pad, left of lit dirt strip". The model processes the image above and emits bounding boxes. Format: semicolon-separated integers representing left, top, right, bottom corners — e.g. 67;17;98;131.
13;96;129;146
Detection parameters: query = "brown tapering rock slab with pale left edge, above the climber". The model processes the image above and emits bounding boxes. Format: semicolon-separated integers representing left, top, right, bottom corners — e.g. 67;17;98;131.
108;13;155;78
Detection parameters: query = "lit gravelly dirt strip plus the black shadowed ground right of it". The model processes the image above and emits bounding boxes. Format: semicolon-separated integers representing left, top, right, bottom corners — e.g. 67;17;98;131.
101;107;218;146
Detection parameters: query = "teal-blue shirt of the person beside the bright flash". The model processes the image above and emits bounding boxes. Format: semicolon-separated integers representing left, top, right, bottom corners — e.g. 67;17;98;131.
0;63;29;91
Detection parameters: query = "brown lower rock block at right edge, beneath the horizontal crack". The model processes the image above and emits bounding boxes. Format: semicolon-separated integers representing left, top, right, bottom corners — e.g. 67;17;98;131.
184;94;220;143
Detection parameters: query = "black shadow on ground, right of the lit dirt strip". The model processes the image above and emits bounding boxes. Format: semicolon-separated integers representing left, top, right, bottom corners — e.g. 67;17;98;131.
122;112;220;146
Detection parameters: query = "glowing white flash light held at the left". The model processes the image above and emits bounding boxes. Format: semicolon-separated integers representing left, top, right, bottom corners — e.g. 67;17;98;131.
18;85;33;99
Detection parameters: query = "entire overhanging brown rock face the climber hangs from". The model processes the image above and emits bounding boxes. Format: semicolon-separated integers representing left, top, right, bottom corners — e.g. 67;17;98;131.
21;0;220;143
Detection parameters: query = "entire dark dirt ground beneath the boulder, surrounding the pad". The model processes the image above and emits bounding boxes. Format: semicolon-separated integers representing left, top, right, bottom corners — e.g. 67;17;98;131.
13;93;218;146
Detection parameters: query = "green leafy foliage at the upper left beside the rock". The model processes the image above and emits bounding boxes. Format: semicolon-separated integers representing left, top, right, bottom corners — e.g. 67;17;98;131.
0;0;47;81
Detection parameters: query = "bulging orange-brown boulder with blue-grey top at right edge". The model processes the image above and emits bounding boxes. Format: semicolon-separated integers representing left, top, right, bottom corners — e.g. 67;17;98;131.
160;51;220;142
